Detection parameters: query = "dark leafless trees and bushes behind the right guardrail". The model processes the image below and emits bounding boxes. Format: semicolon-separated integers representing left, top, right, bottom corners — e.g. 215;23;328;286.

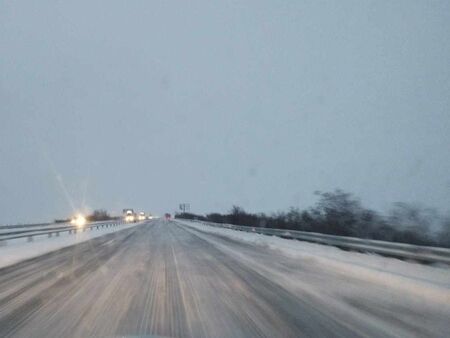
175;189;450;247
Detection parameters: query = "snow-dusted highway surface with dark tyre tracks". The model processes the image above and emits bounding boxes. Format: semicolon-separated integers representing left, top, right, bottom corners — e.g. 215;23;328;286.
0;220;449;337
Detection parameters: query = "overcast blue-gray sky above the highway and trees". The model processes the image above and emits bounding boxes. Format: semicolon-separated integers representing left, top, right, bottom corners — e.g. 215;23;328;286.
0;0;450;223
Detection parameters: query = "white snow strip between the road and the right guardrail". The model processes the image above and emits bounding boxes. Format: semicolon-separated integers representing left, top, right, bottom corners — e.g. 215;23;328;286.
177;220;450;304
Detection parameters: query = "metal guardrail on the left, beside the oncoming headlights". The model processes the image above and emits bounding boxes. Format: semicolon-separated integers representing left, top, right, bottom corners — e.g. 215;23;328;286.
0;221;124;246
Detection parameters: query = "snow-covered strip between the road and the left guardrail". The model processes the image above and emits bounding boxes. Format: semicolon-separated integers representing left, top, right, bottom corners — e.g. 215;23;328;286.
0;223;142;268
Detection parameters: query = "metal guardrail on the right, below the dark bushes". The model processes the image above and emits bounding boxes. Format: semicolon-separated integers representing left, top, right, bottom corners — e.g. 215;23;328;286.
186;221;450;264
